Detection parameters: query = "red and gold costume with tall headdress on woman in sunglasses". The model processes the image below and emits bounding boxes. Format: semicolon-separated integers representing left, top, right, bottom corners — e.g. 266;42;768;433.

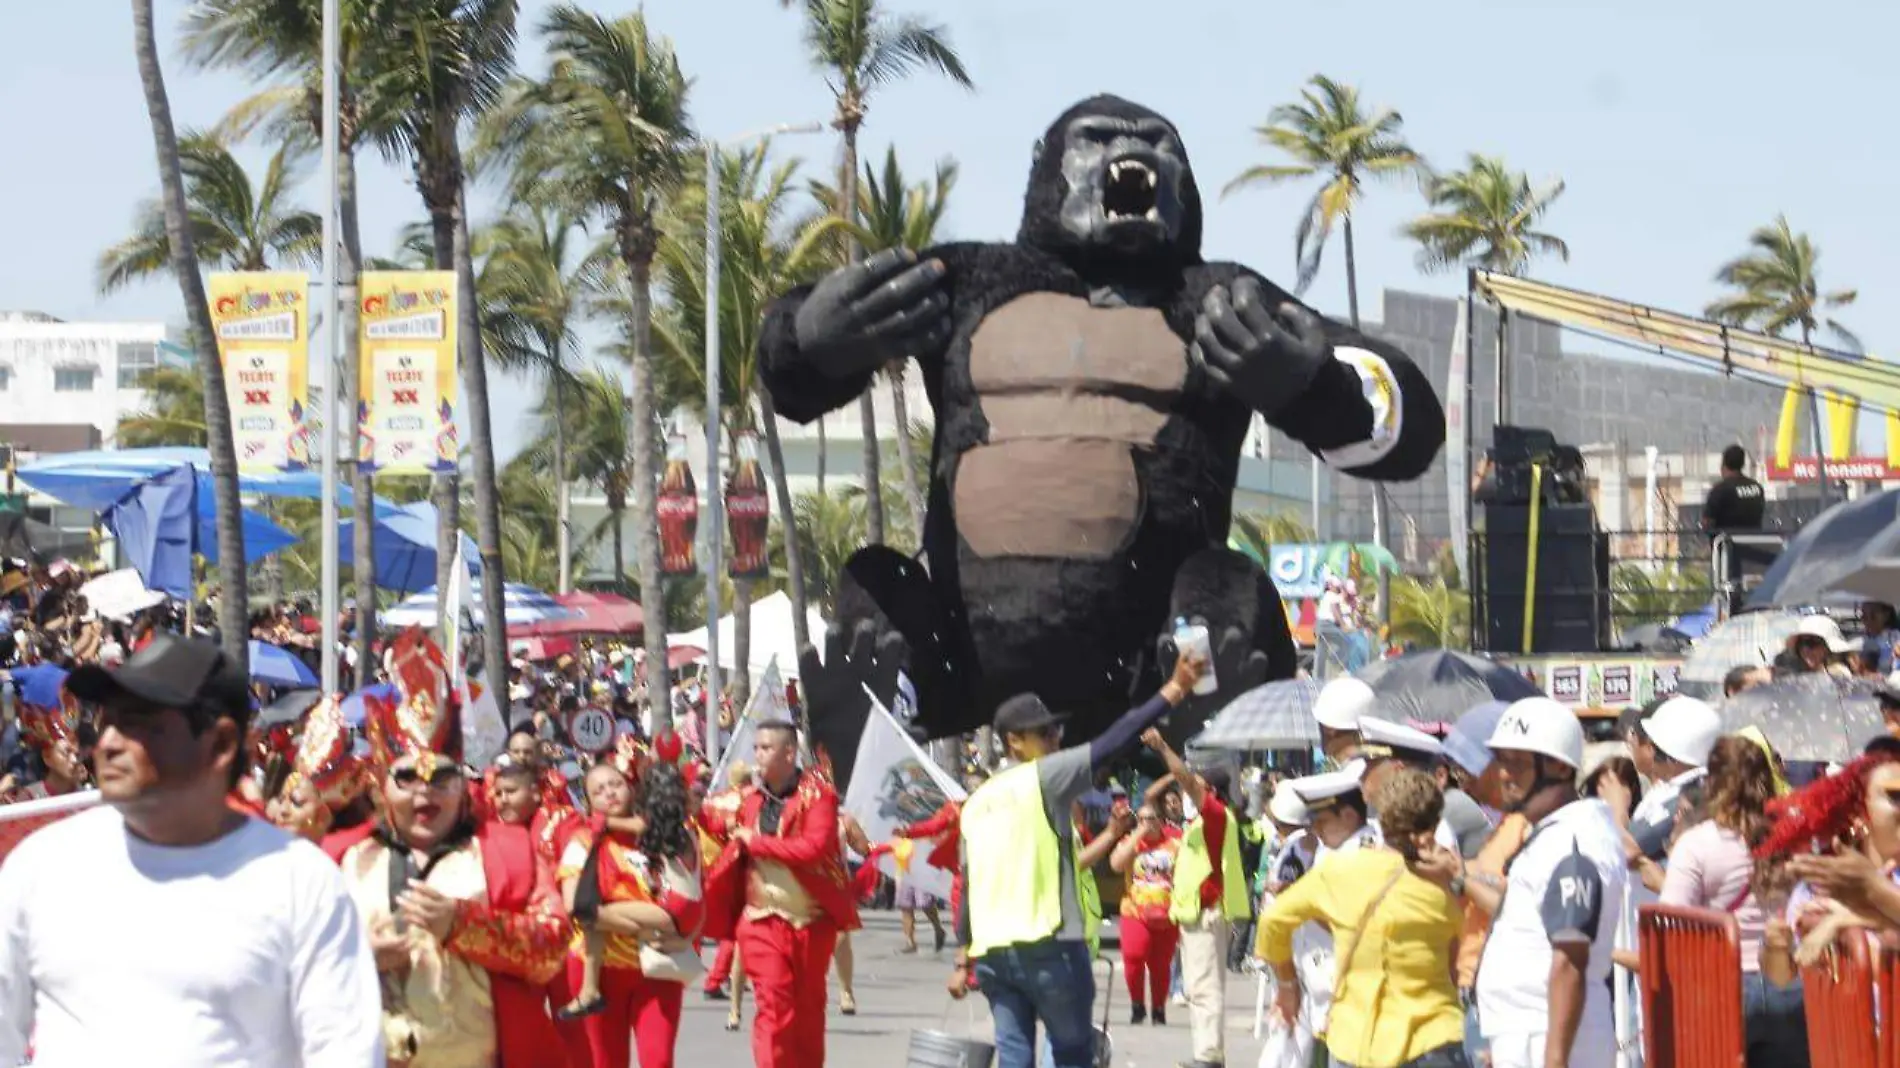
342;629;570;1068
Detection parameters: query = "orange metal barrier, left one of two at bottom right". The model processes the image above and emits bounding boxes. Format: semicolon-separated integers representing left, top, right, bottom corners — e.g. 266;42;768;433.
1636;905;1740;1068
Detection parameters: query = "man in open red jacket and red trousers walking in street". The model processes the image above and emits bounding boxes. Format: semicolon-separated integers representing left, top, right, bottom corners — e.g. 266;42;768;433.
701;720;859;1068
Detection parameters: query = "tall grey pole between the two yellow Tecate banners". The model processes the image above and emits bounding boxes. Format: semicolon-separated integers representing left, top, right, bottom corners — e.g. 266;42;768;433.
317;0;342;694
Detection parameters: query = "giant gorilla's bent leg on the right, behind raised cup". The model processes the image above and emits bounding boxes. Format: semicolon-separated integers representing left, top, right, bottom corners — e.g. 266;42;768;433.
1161;549;1300;745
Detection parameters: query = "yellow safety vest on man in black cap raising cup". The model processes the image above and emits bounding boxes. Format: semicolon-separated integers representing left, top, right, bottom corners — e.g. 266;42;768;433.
961;760;1062;958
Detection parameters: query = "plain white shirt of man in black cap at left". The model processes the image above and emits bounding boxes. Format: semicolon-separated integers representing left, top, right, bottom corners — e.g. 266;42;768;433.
0;806;384;1068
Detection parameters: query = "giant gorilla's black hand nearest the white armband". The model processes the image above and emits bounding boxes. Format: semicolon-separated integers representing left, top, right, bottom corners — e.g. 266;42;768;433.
1191;277;1332;416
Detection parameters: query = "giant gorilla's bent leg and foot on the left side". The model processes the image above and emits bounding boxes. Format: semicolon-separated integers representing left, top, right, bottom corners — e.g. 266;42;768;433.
798;545;952;794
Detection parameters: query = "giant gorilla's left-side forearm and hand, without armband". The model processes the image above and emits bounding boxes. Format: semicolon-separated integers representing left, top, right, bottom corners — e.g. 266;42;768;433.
758;249;950;422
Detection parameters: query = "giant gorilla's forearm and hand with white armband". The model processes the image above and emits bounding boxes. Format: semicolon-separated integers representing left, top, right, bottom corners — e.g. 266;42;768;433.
1191;264;1444;481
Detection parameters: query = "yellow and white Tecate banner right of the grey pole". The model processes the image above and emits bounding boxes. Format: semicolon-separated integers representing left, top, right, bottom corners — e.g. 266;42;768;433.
357;270;460;475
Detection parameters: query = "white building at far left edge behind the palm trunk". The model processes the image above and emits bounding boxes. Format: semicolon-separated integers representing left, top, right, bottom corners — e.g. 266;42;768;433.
0;312;165;443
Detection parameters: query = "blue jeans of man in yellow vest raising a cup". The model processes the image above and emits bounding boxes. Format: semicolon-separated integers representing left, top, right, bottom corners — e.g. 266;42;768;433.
977;941;1094;1068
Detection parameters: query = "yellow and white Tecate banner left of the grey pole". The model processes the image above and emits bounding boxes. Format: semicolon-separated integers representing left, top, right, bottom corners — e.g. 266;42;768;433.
205;272;310;471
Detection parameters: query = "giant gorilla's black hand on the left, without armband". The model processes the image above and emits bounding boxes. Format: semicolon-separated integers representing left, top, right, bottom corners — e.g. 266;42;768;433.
792;249;950;378
